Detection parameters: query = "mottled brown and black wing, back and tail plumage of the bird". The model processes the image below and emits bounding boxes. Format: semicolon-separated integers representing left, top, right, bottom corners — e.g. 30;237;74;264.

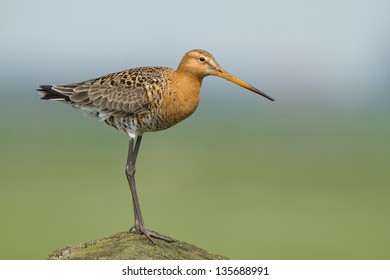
38;67;173;116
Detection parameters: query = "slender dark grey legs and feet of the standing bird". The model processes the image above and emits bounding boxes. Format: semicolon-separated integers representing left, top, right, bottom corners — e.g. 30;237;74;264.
126;136;174;245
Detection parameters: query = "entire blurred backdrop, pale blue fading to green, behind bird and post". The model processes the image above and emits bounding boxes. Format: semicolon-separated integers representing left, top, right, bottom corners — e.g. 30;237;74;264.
0;1;390;259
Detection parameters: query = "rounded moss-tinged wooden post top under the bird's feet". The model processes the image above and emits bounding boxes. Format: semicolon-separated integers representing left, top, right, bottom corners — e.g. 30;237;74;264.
48;232;227;260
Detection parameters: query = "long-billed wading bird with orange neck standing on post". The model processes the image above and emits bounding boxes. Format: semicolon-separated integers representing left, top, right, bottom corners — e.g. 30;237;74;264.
37;49;274;245
